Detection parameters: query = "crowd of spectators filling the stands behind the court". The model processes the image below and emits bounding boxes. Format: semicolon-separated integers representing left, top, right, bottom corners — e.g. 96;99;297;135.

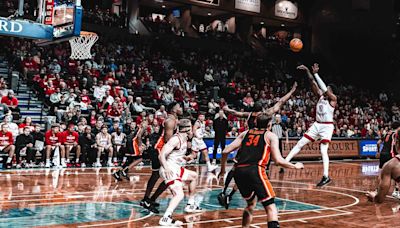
0;17;400;167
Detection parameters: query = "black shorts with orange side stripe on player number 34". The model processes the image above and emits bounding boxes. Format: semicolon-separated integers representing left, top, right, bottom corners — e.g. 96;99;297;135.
234;165;275;206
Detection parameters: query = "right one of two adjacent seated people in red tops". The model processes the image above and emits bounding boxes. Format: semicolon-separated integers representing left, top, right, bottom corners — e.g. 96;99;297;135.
62;124;81;167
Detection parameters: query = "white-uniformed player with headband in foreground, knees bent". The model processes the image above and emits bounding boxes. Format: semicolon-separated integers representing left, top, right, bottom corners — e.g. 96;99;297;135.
159;119;202;226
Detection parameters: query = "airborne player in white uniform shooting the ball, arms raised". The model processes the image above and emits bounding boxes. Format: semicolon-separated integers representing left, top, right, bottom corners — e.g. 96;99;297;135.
286;63;337;187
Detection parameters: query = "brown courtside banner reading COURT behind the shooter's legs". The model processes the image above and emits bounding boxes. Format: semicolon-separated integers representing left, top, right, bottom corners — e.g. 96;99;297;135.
281;140;359;158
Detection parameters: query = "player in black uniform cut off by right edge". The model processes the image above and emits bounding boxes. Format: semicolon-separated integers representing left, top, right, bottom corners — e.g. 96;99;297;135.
376;121;400;198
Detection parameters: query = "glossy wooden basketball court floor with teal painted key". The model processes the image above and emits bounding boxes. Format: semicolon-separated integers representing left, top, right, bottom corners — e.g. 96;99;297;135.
0;161;400;227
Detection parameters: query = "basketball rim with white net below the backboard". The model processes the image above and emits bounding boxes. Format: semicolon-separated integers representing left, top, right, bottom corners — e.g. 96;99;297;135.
69;31;99;60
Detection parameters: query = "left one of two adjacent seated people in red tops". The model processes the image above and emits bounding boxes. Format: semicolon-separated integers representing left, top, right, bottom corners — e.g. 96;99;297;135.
44;124;67;168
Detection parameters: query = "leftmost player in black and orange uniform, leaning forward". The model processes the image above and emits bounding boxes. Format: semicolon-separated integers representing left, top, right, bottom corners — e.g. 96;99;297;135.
113;121;147;181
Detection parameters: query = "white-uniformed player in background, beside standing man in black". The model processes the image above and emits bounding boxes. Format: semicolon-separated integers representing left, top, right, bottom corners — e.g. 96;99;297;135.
192;114;217;172
